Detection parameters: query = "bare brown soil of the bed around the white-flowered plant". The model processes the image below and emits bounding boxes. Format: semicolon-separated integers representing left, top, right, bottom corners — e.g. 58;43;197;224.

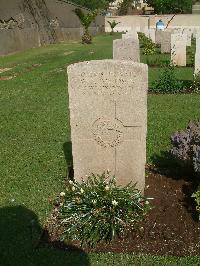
43;172;200;256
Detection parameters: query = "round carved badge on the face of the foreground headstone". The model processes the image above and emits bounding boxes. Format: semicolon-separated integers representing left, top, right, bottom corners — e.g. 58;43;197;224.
92;118;124;148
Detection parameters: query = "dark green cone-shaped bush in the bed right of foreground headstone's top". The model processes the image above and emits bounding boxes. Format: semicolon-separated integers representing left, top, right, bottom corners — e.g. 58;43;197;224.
150;63;184;93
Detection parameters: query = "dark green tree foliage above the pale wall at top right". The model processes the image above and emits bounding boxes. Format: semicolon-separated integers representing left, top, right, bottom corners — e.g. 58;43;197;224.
146;0;192;14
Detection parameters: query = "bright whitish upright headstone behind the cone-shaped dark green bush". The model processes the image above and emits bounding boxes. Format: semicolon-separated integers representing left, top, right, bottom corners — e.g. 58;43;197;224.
171;34;187;66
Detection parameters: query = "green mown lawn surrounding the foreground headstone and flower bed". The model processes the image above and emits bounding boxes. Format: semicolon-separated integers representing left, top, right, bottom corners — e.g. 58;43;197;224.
0;34;200;266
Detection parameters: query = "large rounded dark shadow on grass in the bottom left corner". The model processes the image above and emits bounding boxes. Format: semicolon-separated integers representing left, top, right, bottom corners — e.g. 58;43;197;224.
0;206;90;266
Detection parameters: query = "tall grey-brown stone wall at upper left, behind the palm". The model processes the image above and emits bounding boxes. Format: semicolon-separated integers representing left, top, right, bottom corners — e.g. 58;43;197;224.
0;0;105;55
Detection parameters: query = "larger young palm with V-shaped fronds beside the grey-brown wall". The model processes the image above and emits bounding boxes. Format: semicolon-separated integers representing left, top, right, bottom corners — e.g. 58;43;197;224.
74;8;98;44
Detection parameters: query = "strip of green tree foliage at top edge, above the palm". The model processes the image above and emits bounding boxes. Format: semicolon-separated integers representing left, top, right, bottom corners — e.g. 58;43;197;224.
71;0;114;10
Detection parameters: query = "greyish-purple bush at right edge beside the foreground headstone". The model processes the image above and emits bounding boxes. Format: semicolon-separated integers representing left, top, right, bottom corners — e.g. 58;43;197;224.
171;121;200;173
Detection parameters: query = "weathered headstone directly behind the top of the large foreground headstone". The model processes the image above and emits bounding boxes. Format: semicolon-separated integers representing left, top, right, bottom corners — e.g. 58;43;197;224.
113;38;140;62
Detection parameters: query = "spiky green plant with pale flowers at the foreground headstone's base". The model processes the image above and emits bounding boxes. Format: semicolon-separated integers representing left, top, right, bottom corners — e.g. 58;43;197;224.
61;173;150;246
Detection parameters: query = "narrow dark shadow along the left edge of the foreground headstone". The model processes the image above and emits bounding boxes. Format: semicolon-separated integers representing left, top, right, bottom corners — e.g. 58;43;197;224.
63;141;74;180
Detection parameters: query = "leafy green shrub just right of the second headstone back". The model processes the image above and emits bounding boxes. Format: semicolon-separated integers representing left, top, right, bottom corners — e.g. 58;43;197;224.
138;32;156;55
